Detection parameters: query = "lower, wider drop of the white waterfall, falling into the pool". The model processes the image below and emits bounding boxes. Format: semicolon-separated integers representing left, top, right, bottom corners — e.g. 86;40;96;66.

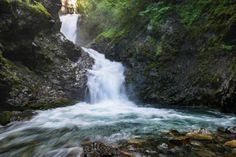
83;48;126;103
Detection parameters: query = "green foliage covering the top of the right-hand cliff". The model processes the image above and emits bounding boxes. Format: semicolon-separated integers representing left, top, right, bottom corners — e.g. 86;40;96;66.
78;0;236;56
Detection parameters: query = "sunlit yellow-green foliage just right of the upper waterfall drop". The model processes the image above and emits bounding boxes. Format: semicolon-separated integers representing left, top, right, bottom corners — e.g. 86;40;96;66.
77;0;147;37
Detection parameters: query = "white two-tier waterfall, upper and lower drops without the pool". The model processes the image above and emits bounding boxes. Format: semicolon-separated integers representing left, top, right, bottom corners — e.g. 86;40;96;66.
60;14;127;103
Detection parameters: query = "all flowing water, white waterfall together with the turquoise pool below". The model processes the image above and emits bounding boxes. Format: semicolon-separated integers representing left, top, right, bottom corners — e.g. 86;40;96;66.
0;11;236;157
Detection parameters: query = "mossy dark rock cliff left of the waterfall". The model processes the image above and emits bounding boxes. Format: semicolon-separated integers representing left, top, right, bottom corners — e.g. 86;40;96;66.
0;0;93;111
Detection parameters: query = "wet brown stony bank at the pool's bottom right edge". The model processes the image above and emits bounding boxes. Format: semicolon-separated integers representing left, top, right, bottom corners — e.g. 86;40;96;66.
102;128;236;157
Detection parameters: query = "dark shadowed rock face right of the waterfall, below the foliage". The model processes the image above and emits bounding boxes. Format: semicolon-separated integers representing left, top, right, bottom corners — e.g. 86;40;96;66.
92;27;236;113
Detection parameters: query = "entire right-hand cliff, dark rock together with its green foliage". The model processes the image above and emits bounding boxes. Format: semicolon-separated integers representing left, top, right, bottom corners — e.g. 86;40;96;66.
79;0;236;113
